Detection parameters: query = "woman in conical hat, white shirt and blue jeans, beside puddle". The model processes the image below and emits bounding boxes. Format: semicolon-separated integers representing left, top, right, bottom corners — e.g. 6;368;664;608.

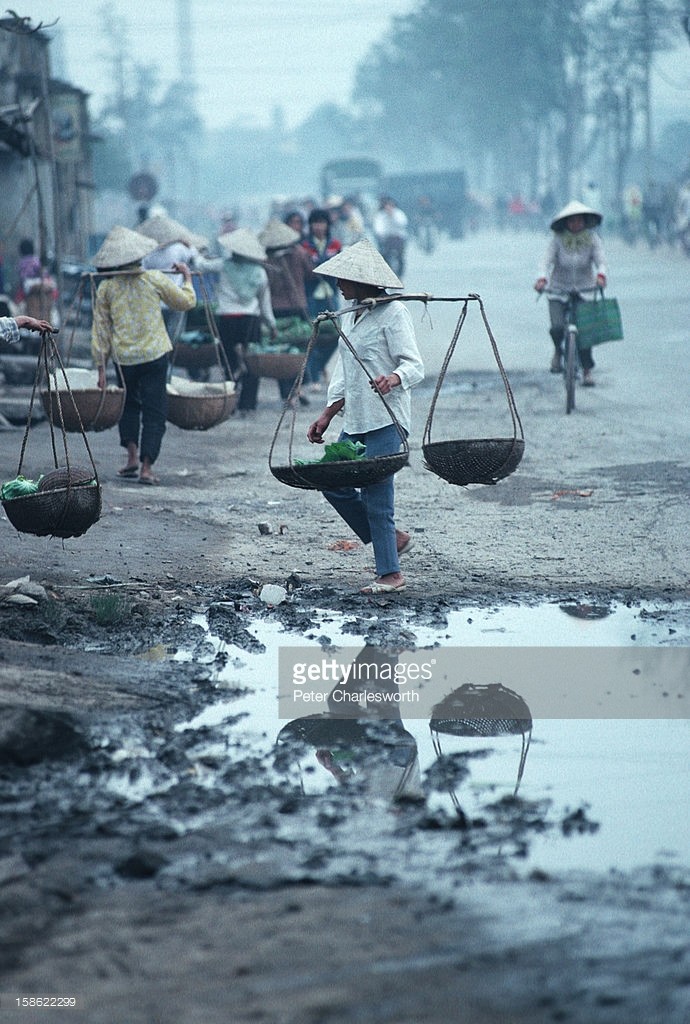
307;239;424;594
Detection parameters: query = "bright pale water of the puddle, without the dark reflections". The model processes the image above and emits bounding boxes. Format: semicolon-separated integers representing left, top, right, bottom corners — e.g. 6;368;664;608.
177;604;690;871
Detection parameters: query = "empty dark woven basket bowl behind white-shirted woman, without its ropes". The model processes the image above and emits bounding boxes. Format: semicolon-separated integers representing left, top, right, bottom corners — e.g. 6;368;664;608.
422;437;525;484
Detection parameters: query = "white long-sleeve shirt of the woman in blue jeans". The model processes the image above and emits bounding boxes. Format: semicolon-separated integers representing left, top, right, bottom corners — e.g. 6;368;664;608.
327;301;424;434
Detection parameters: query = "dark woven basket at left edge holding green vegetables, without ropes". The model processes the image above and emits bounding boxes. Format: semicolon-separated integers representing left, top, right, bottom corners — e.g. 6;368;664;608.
2;467;101;538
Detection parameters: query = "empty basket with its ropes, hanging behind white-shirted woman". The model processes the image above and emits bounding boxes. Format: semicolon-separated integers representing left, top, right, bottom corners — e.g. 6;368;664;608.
422;295;525;485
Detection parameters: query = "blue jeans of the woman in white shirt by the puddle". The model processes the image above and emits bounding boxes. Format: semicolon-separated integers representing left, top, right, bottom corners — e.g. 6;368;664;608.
324;423;400;577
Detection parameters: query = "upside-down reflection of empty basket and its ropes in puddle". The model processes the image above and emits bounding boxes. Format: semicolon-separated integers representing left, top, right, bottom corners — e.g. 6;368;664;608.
429;683;532;796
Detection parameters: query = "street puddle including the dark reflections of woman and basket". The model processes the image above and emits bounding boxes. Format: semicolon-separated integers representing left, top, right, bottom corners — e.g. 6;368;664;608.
178;604;690;871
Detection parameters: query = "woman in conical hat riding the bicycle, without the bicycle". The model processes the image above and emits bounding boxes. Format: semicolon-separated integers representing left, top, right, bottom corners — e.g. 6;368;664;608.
534;201;606;387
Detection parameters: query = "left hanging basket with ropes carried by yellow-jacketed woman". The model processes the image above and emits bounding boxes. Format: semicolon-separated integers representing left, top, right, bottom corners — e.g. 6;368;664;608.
41;273;126;433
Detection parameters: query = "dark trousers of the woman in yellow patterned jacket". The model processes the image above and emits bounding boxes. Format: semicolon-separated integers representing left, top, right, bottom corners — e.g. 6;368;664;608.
117;355;168;465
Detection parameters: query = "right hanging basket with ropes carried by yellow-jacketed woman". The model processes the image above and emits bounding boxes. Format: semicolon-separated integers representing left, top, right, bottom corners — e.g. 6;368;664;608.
166;270;238;430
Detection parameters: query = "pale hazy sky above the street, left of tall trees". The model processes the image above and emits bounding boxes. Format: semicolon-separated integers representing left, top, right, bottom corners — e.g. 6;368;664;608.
29;0;417;127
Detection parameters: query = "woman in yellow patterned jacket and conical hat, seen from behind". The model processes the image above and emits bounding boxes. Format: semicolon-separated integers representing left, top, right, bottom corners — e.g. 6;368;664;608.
91;227;197;484
